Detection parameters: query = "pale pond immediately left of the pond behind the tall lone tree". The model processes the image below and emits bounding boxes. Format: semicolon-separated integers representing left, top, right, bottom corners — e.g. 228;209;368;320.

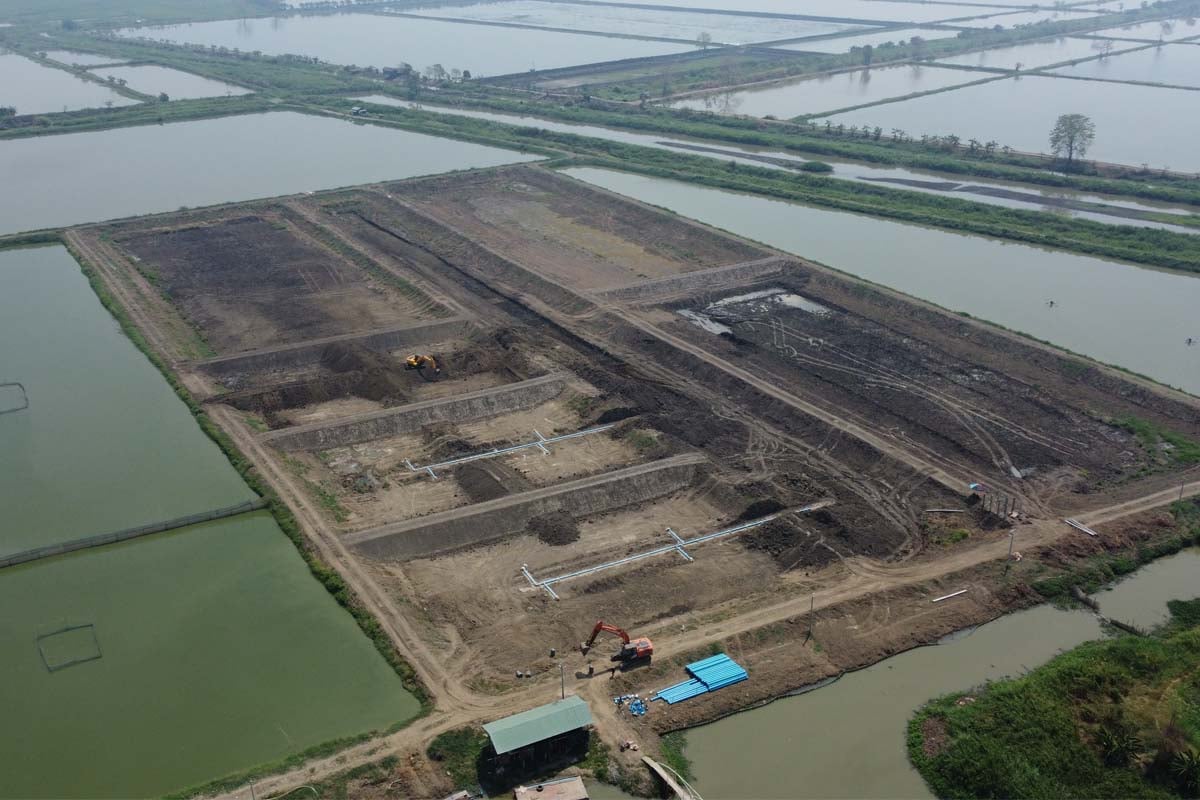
672;64;986;119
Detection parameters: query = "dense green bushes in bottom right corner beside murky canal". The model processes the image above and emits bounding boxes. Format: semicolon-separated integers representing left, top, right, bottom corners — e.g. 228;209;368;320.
908;600;1200;798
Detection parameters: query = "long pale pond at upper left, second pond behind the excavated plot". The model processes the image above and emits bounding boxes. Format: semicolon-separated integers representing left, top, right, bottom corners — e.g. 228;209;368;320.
118;13;692;78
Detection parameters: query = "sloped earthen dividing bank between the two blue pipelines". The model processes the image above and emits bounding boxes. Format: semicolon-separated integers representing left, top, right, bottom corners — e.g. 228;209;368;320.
346;455;707;559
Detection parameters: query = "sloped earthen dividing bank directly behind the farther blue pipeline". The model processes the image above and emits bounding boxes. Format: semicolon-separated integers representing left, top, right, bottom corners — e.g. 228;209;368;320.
260;374;566;451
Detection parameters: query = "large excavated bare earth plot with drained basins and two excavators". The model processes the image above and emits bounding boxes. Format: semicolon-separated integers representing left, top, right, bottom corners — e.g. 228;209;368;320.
73;160;1200;792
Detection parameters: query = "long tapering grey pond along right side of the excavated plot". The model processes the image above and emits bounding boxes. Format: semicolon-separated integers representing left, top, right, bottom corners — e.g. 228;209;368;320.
566;168;1200;393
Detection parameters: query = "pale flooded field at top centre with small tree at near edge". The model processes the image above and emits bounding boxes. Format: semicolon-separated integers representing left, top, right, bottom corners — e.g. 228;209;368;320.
413;0;852;44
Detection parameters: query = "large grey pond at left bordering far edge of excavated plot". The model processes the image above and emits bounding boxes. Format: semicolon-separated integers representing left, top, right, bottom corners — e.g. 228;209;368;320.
0;112;532;234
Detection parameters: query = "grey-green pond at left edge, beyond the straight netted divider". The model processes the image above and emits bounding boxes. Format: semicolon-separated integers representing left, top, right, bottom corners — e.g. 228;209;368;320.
0;247;253;556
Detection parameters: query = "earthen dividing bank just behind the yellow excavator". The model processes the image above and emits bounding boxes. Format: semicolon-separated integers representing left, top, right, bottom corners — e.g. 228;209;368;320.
196;317;473;379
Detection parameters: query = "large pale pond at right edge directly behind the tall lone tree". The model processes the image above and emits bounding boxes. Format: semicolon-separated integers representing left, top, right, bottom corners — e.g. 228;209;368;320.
833;76;1200;172
